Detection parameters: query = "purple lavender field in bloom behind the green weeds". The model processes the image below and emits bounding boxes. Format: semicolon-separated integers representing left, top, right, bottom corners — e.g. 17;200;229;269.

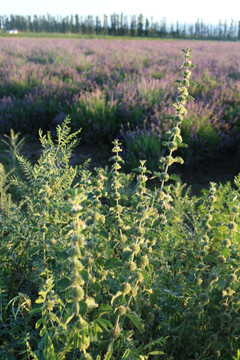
0;38;240;167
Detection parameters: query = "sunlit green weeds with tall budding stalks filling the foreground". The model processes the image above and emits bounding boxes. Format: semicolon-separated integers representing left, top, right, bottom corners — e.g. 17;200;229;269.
0;49;240;360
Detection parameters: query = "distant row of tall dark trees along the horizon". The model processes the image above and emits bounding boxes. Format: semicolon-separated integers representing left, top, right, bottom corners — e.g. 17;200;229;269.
0;14;240;40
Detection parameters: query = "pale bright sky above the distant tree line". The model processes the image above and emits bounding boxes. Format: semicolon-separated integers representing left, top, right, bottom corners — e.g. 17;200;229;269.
0;0;240;24
